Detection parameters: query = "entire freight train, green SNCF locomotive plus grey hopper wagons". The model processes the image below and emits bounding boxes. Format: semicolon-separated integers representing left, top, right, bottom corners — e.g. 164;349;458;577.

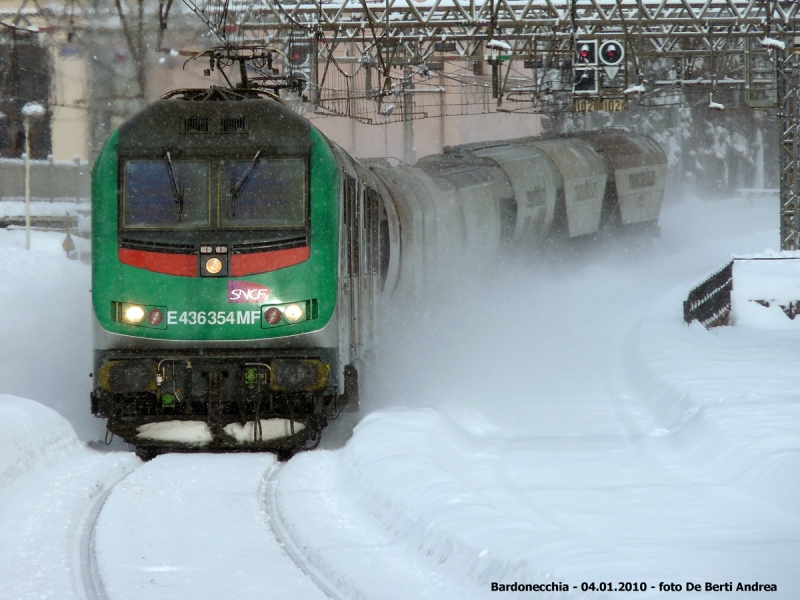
91;88;667;456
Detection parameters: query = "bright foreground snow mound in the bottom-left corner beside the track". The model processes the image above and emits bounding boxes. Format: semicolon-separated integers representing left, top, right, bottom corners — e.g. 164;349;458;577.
0;395;140;600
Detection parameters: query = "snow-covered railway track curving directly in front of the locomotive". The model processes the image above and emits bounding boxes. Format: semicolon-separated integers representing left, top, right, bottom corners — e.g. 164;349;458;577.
83;453;334;600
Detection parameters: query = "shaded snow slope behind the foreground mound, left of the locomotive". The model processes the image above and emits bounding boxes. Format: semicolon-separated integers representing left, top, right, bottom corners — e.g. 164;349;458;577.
0;229;99;440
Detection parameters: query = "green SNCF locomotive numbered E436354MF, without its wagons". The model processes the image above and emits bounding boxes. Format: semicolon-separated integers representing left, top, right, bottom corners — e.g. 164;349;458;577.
91;89;386;454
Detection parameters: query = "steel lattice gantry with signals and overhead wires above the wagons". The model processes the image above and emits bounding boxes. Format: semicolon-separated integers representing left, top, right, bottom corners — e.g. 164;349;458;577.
181;0;800;249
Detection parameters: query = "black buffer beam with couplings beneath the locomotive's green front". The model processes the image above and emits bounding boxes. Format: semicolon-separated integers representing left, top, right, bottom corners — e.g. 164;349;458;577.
92;349;337;422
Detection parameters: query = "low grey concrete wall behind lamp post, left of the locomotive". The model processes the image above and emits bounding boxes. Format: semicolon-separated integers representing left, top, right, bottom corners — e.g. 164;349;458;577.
0;158;91;202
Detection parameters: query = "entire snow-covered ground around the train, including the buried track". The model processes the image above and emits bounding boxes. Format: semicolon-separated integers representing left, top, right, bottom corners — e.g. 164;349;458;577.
0;199;800;600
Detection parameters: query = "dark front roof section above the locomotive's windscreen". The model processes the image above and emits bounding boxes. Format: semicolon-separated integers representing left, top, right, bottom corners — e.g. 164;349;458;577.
119;98;311;158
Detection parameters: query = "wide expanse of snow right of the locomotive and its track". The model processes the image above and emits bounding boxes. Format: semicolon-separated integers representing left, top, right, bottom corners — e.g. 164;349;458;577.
278;195;800;600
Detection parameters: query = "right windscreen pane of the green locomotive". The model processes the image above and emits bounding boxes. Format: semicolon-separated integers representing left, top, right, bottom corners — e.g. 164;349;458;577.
218;157;307;229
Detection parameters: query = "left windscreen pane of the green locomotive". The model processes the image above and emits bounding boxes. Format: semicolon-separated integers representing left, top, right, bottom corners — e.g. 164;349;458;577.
122;158;210;229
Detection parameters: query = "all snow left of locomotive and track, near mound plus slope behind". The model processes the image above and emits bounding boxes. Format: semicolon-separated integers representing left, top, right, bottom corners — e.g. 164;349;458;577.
0;229;141;600
